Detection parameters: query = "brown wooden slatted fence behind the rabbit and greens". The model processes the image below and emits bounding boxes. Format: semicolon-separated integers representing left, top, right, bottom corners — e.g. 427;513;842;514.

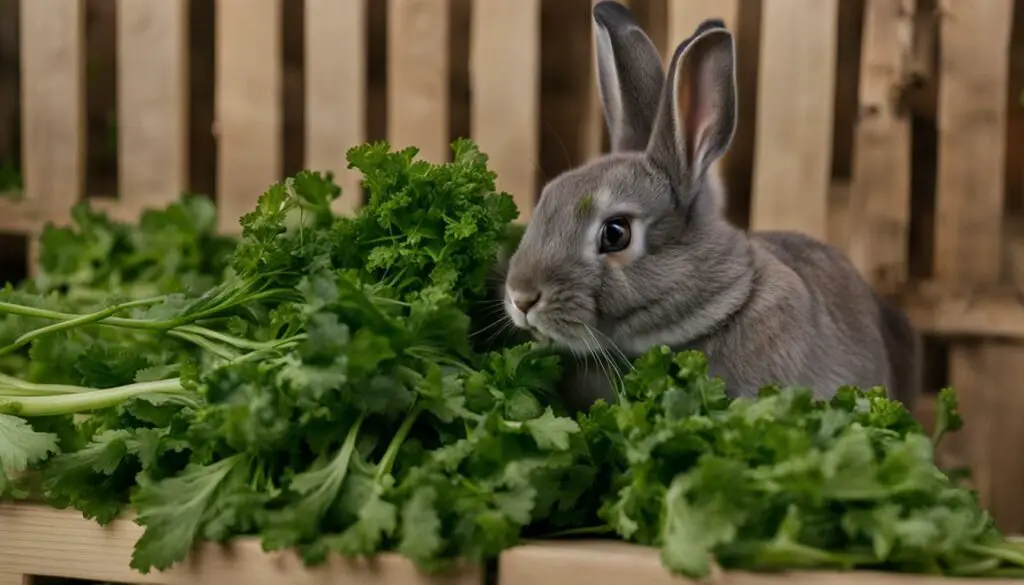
0;0;1024;532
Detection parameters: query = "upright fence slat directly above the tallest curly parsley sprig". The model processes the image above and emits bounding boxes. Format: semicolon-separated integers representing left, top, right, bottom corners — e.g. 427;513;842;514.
387;0;446;163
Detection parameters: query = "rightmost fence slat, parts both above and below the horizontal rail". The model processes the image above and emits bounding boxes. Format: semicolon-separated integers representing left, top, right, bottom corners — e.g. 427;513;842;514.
934;0;1024;531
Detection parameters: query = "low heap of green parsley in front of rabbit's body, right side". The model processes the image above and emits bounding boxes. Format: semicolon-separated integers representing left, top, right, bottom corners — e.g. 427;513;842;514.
583;347;1024;578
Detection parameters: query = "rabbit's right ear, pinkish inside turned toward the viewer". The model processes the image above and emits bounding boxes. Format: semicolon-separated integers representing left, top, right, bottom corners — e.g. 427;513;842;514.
647;19;736;192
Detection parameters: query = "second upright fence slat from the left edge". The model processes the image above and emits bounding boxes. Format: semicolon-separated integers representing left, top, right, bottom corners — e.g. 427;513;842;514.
116;0;188;214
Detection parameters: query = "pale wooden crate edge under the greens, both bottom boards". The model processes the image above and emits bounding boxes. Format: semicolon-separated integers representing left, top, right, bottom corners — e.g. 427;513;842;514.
0;504;1019;585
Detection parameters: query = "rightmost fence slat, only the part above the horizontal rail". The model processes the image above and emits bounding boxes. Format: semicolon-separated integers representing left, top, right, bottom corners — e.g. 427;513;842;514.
935;0;1014;284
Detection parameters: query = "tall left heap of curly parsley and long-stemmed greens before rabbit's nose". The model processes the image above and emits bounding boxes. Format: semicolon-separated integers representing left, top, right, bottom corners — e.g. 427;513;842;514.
0;140;594;572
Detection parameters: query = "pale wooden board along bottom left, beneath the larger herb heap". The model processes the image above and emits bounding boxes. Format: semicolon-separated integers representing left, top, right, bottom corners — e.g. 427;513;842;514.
0;504;483;585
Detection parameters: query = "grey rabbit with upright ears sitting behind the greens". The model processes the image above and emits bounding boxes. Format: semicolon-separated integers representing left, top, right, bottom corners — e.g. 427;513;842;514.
502;0;920;412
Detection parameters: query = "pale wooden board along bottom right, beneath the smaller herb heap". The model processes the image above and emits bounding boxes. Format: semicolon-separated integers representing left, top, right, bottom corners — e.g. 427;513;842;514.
498;541;1020;585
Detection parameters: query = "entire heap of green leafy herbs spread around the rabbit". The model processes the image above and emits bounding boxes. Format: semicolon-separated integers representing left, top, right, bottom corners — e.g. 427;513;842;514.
0;140;1024;577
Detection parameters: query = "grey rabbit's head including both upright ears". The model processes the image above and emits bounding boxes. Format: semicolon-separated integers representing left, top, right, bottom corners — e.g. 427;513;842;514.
505;1;751;354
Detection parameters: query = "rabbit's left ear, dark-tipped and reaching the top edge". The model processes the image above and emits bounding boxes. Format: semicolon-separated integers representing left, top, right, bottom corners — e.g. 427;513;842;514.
594;0;665;152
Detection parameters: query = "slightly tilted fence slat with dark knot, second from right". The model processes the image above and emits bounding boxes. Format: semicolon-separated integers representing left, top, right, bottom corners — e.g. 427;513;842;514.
849;0;915;293
